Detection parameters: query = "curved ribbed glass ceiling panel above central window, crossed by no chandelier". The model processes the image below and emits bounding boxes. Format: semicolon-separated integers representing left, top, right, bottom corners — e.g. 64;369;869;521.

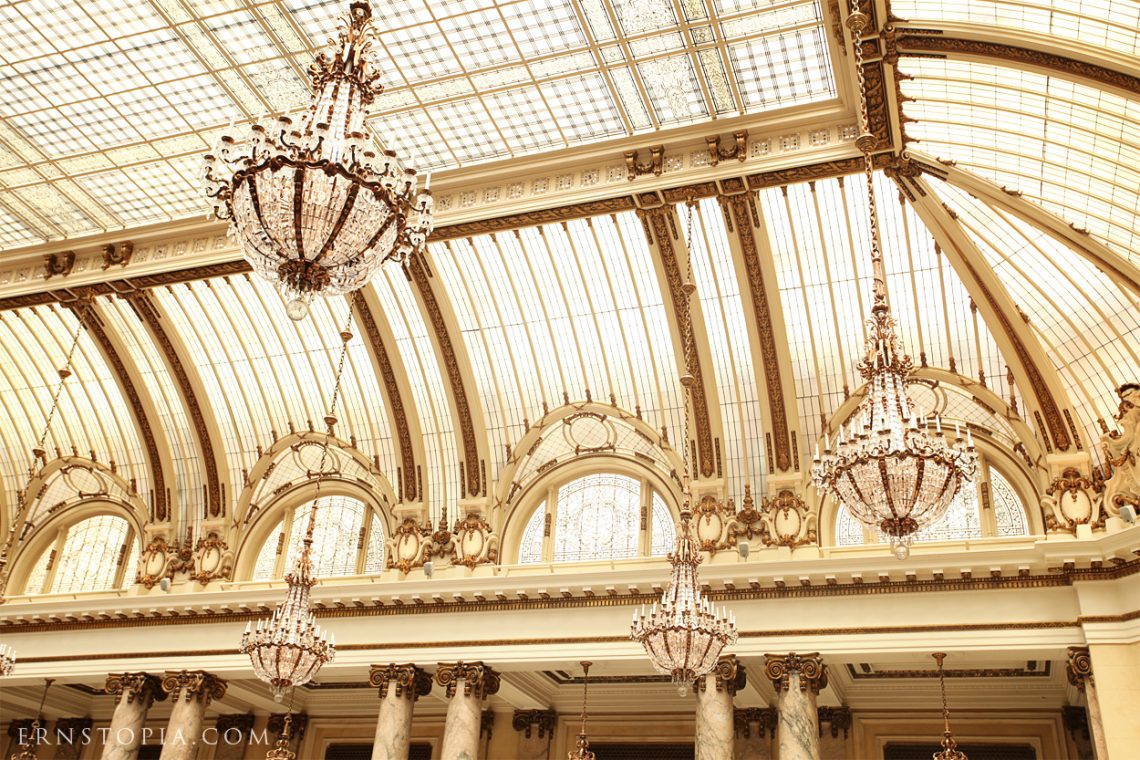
430;213;681;481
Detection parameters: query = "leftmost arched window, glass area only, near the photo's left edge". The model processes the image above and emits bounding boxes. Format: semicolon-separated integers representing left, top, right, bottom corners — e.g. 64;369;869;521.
24;515;139;594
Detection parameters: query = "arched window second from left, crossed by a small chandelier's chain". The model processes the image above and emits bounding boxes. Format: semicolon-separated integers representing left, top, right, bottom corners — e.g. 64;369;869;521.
253;496;384;580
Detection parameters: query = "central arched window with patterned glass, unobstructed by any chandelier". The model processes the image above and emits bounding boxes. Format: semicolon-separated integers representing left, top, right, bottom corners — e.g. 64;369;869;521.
519;473;675;564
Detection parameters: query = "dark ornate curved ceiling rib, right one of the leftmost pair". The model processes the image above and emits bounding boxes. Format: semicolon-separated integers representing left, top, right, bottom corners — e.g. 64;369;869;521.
125;291;227;522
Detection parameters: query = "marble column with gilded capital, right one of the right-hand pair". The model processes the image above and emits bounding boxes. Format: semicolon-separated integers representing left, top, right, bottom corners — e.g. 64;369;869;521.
764;652;828;760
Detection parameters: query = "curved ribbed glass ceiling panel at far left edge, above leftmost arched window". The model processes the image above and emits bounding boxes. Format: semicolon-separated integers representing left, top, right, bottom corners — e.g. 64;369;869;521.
0;308;150;509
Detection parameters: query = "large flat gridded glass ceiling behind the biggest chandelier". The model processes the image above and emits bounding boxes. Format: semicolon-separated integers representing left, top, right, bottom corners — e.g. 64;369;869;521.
0;0;836;247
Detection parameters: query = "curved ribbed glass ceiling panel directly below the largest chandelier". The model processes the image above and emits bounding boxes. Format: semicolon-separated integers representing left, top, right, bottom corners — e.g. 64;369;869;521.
155;276;396;497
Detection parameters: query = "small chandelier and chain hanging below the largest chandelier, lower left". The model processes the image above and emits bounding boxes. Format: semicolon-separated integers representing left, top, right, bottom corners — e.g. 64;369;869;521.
239;294;358;702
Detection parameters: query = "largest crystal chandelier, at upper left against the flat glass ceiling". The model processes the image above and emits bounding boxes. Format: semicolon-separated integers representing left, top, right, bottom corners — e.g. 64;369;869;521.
205;0;433;319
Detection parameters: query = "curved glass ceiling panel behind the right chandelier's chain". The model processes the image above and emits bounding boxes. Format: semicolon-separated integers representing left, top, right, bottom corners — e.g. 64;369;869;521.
759;173;1021;456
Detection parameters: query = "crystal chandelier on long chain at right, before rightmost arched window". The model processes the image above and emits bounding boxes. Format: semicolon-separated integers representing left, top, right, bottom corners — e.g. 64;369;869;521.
812;0;977;559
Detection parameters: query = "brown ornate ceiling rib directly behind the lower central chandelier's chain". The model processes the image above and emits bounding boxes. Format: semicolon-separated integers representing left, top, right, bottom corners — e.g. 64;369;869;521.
637;205;716;477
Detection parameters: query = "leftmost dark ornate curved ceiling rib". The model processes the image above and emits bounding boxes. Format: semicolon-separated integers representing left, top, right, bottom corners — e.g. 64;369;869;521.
64;300;173;523
